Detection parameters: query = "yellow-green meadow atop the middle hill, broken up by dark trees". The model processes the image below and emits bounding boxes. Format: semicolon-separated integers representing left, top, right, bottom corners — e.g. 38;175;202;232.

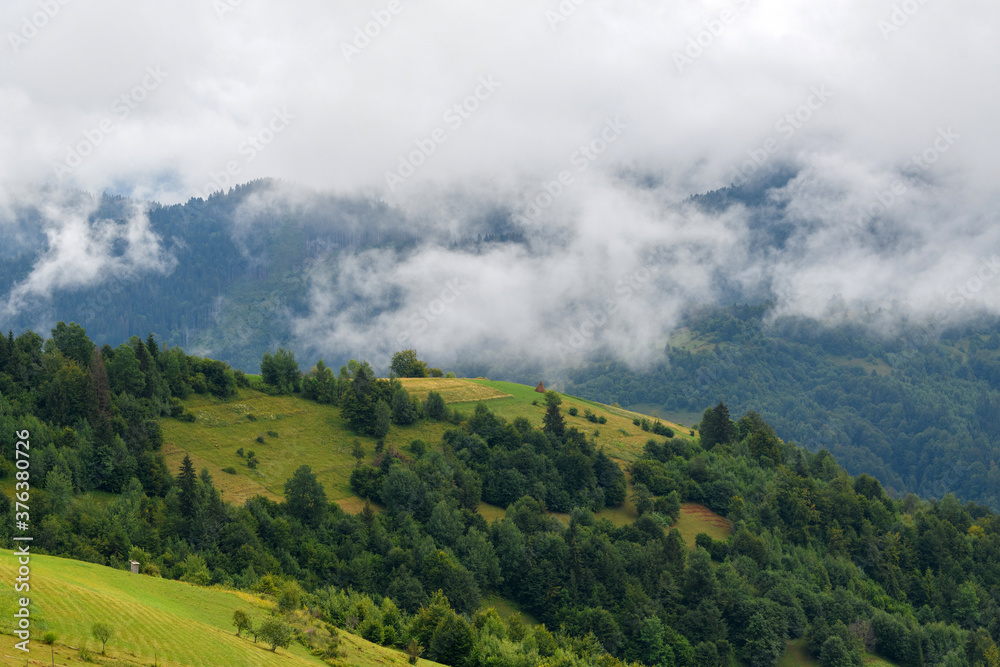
160;378;688;506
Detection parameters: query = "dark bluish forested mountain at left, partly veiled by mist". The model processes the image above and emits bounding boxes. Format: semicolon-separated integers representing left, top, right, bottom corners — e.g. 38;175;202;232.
0;180;521;372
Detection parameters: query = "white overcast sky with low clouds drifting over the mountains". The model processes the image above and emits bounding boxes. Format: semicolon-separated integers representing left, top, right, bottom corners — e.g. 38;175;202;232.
0;0;1000;366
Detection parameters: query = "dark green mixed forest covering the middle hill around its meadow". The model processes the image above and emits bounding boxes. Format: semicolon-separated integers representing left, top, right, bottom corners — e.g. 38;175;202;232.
0;324;1000;667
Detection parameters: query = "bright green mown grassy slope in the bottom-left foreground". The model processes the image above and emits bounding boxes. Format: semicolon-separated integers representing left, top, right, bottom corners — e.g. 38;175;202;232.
0;550;435;667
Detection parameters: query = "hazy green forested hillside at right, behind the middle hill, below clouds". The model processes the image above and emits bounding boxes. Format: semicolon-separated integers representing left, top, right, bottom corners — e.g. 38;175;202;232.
566;306;1000;509
